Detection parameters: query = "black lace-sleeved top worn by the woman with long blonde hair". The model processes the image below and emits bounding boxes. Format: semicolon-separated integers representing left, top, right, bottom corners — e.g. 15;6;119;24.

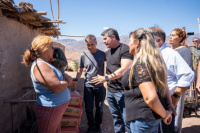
122;62;165;121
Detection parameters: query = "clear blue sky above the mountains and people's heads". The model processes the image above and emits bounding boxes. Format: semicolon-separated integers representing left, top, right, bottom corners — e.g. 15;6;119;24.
14;0;200;40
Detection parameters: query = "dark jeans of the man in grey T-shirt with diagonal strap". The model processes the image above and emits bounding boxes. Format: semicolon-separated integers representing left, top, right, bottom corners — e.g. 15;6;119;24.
84;87;106;127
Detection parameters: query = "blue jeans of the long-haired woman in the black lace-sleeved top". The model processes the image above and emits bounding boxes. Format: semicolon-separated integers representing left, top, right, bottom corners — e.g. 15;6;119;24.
130;119;161;133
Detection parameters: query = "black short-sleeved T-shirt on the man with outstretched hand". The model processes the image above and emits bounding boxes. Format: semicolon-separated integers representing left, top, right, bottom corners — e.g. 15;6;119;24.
106;43;133;92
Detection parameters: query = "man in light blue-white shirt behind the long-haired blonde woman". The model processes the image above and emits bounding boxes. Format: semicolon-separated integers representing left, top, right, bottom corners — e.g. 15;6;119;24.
150;27;195;133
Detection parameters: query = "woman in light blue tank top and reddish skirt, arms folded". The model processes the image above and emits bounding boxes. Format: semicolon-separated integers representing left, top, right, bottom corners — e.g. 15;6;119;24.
23;35;72;133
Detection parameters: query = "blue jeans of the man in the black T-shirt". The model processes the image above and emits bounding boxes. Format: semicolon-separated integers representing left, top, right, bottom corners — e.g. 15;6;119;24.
107;91;131;133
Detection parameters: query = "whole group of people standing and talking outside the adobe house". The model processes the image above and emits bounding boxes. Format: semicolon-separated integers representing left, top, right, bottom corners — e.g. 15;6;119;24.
23;27;200;133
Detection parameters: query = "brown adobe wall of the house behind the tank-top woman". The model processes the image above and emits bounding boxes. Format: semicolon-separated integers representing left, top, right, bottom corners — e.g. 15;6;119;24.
0;10;40;133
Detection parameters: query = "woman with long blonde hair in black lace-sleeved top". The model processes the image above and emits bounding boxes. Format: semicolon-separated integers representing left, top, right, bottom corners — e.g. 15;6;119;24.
122;29;172;133
